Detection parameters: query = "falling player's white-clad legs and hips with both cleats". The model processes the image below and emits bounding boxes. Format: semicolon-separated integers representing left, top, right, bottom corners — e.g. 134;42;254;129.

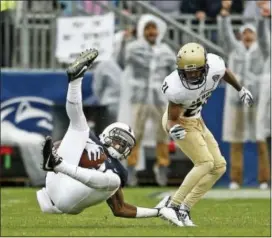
37;50;120;213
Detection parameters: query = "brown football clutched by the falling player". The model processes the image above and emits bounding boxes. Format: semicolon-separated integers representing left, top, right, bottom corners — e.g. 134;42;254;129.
54;140;107;169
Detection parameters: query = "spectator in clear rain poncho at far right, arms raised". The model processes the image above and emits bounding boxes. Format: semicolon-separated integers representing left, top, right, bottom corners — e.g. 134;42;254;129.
221;11;269;189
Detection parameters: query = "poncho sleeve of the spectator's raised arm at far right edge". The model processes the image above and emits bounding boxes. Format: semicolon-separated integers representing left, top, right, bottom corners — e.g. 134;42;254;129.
257;19;270;59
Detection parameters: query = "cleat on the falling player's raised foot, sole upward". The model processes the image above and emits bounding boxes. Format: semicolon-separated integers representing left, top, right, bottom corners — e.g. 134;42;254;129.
66;49;98;83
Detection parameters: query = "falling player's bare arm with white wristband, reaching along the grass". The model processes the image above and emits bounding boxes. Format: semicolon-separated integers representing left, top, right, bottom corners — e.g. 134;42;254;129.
107;188;160;218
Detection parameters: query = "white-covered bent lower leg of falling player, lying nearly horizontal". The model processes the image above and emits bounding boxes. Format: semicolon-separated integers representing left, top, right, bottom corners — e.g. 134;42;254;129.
54;160;120;191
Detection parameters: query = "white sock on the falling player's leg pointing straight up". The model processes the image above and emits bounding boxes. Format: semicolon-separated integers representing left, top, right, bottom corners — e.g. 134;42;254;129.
66;78;89;131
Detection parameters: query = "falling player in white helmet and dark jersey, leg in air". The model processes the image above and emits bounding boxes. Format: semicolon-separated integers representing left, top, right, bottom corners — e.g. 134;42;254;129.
37;50;164;218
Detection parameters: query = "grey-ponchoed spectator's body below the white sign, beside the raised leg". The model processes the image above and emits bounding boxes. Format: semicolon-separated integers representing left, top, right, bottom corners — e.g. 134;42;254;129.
93;59;122;125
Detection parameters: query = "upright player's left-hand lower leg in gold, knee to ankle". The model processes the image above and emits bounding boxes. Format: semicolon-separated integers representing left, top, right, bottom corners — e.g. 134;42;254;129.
171;162;213;206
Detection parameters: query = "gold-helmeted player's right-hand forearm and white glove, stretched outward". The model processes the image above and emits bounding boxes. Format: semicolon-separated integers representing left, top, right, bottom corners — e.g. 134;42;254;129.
223;69;254;107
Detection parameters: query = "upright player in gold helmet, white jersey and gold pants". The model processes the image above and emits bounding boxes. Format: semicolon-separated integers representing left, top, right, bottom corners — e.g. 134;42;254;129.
160;43;253;226
